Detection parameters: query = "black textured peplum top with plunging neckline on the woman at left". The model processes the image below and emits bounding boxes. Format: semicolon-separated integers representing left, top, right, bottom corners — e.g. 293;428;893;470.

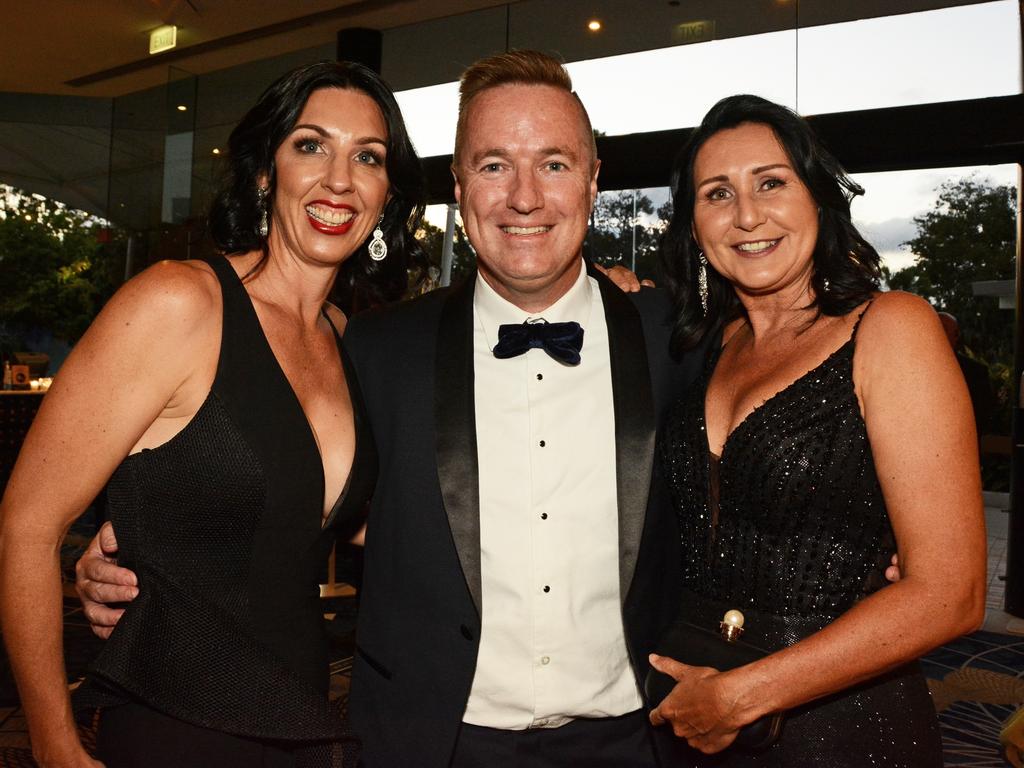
76;258;376;740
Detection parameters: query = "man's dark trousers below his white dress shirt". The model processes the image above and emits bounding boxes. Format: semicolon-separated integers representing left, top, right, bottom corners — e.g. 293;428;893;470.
451;710;657;768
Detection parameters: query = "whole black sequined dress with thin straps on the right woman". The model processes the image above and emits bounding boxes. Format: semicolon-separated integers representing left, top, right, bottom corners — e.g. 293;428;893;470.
659;319;942;768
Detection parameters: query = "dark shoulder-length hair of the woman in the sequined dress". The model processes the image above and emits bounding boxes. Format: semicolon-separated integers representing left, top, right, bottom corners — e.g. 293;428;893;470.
660;95;882;355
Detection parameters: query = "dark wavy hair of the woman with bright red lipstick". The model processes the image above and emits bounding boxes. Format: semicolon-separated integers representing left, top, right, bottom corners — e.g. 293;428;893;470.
210;61;426;312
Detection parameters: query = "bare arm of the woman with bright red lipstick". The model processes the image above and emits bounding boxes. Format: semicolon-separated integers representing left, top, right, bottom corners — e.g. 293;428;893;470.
0;262;220;766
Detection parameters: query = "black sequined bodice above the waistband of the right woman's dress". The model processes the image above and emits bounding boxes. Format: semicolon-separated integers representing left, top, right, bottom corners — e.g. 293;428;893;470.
662;339;895;616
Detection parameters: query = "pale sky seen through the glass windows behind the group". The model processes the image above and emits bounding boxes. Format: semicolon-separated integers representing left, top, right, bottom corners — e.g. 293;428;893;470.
397;0;1022;269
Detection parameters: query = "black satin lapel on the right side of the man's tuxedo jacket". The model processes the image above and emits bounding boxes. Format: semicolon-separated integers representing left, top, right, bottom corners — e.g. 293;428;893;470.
590;269;657;602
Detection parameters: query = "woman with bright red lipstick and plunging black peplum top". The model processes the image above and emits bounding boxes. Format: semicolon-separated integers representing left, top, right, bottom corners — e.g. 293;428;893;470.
0;62;423;768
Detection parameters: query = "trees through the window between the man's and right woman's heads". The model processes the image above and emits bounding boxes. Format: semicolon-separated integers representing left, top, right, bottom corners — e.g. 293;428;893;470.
587;189;667;280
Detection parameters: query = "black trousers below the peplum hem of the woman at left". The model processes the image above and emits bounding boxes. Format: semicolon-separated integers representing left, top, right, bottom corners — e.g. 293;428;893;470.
96;702;295;768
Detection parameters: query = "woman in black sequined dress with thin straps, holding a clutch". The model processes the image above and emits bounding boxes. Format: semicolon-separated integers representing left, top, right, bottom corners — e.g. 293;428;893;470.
651;96;985;768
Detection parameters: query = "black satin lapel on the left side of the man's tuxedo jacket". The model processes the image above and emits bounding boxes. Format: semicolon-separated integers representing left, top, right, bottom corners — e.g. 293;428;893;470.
434;272;481;612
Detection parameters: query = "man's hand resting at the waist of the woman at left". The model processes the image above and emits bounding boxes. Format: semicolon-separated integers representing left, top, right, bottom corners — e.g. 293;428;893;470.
75;522;138;639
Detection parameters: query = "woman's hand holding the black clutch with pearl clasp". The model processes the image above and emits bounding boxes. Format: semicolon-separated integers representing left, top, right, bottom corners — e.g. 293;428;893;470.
649;653;758;755
